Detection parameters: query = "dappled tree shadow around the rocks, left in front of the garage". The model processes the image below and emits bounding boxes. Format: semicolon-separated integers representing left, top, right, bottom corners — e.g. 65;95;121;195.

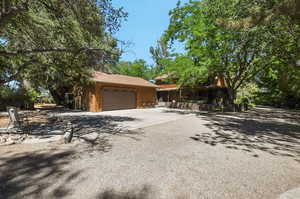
24;110;141;152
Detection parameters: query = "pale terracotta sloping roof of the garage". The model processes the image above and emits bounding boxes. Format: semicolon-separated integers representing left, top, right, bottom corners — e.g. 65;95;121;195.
92;72;158;88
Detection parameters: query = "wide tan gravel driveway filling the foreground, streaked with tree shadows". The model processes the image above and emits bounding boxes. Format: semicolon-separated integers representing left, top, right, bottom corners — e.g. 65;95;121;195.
0;109;300;199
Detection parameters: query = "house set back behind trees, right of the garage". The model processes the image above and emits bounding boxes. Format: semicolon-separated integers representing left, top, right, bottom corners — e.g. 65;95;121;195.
155;73;227;104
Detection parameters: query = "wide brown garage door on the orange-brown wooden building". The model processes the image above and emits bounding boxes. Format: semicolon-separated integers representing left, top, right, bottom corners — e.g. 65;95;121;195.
102;88;136;111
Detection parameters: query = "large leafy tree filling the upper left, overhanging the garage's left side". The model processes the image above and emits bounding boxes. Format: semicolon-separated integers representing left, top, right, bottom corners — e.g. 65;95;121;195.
0;0;127;103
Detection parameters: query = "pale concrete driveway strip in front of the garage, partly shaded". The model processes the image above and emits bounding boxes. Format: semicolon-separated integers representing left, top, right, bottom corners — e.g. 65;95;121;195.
18;108;192;144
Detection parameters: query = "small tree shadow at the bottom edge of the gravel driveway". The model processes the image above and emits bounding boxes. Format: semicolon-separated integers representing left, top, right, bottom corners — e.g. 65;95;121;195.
96;185;156;199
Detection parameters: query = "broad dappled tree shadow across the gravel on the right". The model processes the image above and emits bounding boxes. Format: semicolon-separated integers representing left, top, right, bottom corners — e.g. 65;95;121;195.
191;106;300;161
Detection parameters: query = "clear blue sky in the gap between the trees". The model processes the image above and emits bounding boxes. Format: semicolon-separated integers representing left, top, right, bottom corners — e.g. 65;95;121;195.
113;0;186;64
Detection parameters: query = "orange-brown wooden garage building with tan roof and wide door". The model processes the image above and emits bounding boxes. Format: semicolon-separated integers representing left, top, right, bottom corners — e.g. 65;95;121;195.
75;72;157;112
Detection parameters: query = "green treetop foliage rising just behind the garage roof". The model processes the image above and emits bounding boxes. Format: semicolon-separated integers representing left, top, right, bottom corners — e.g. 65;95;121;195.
115;59;154;80
